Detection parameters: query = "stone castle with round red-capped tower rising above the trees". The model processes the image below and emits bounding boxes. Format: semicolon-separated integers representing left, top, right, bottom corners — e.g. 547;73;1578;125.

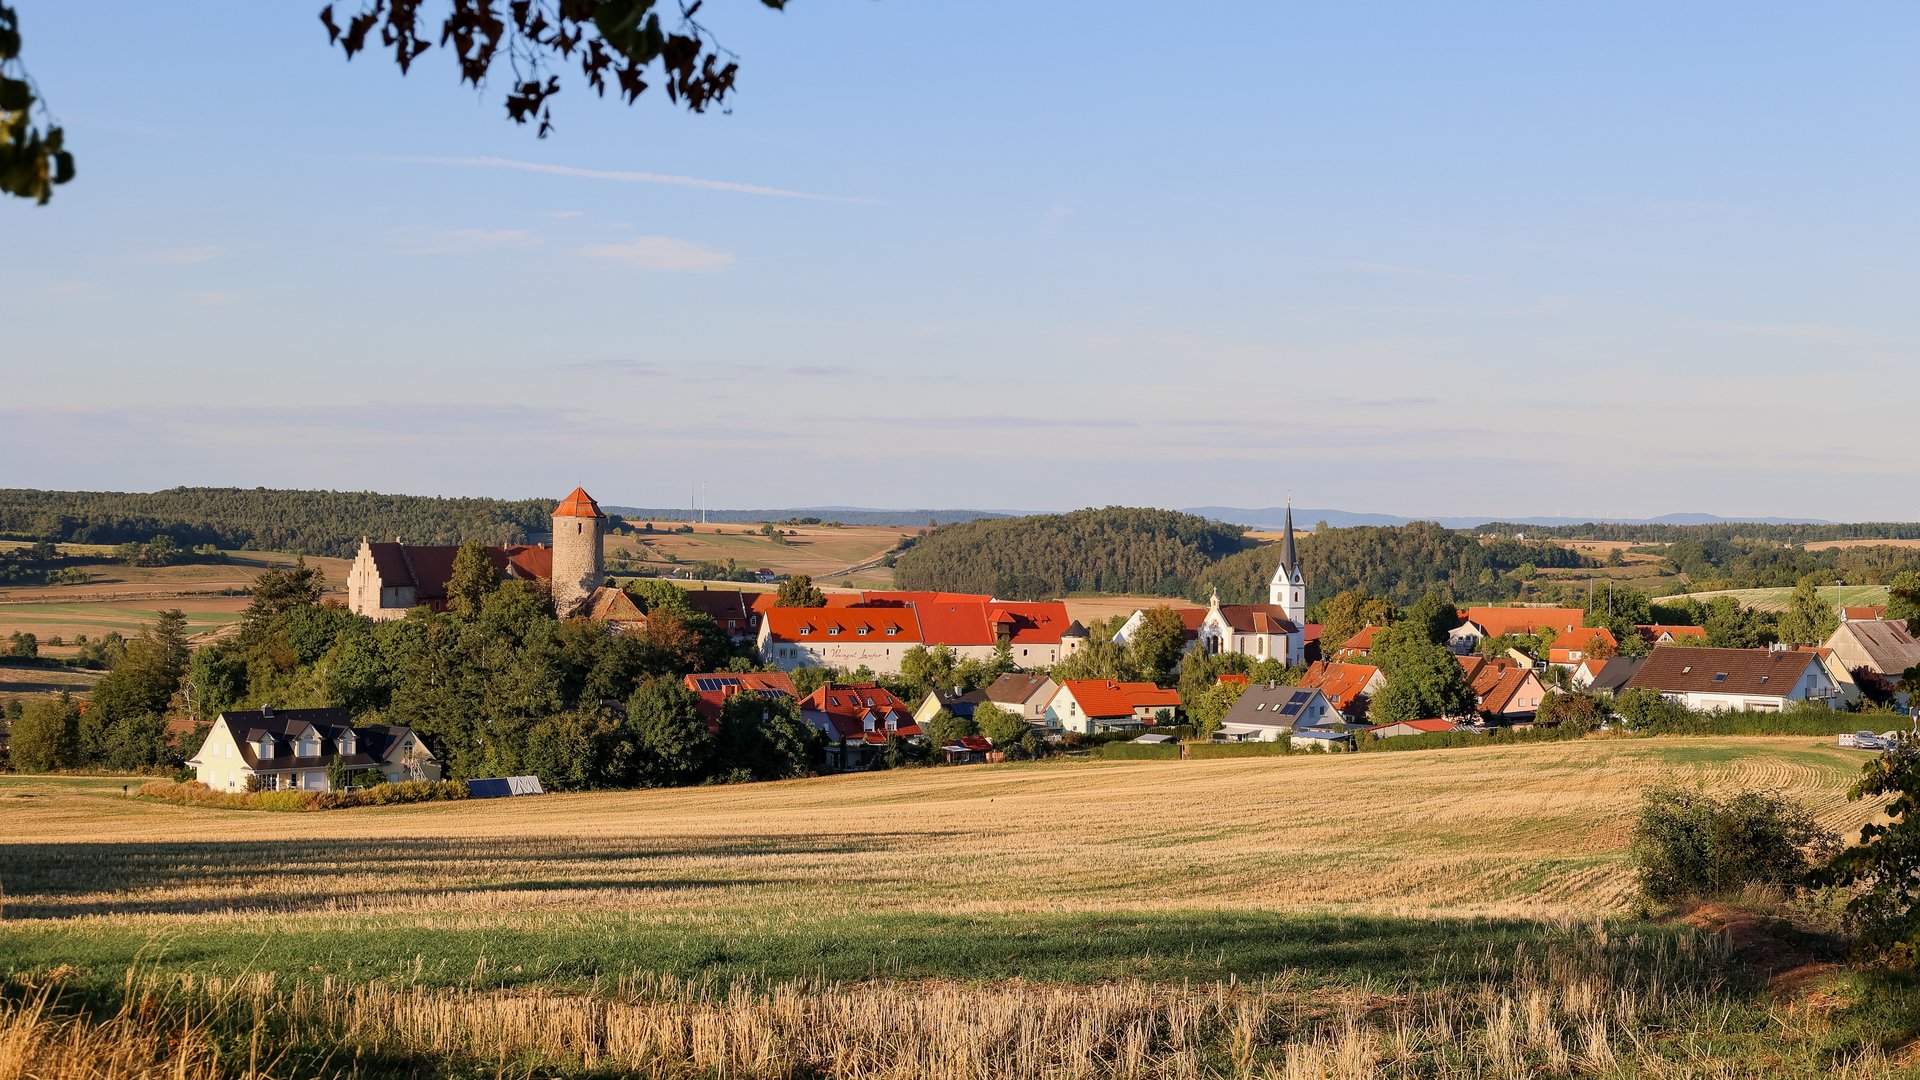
348;488;606;619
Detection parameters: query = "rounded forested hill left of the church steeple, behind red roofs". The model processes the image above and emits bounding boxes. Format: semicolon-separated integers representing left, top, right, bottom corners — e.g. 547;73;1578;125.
893;507;1248;600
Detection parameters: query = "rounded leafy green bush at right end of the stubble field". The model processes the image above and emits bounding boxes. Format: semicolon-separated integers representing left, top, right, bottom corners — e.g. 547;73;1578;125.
1632;784;1839;903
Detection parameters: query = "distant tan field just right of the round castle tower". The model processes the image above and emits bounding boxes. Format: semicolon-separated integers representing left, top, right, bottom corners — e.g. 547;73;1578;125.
607;523;920;580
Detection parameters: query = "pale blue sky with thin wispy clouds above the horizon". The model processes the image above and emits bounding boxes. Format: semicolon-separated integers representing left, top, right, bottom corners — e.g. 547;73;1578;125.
0;0;1920;521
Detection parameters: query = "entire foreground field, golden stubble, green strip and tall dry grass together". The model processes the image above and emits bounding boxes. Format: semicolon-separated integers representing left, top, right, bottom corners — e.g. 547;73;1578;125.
0;738;1920;1078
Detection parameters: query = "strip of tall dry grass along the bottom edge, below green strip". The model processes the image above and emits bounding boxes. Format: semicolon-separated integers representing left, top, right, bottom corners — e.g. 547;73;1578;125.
0;926;1897;1080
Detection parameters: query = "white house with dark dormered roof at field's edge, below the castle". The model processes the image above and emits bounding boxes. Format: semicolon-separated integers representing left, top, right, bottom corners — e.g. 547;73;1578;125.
186;707;440;792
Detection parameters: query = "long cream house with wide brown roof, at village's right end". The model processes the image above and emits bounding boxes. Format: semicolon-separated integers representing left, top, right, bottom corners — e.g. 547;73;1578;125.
1626;646;1839;713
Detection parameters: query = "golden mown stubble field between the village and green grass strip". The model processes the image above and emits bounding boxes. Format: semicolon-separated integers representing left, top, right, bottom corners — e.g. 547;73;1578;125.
0;738;1872;924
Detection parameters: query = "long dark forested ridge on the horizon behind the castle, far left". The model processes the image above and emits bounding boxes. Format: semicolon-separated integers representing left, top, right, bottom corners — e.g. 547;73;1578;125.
0;488;555;557
